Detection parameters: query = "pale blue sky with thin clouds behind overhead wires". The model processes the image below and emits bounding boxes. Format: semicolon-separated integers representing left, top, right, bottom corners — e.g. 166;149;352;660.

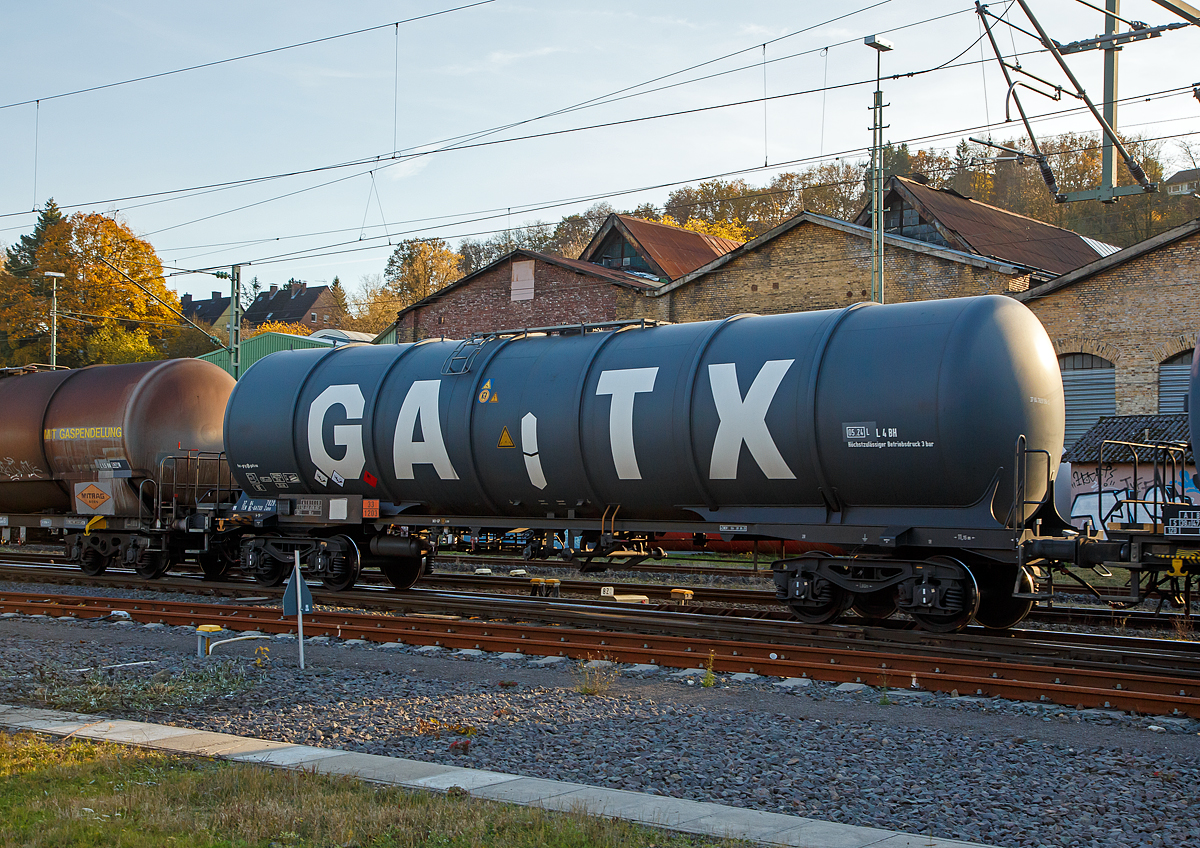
0;0;1200;297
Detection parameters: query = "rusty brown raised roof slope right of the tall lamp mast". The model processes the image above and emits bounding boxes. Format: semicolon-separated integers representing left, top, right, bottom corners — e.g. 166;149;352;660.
894;176;1100;273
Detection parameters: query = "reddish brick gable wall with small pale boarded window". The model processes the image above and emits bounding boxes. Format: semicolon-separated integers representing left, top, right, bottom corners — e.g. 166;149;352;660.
386;249;656;343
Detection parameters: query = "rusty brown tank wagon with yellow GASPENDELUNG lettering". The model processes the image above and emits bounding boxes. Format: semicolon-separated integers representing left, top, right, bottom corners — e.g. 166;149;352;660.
0;359;234;571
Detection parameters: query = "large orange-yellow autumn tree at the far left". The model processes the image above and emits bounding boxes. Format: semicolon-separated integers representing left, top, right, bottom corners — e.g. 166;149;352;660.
0;212;179;367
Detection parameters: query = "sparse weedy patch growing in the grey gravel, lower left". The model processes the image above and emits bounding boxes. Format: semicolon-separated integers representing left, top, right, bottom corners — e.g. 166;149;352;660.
30;660;253;712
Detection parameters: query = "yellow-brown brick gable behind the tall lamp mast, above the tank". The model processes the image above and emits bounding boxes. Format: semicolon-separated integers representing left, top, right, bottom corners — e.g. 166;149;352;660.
643;212;1033;321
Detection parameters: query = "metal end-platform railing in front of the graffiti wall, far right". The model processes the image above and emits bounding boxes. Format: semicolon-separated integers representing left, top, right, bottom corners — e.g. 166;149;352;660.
1096;439;1192;530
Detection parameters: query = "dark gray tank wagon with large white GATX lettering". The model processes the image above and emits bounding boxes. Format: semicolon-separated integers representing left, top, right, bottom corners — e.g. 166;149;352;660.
224;297;1064;629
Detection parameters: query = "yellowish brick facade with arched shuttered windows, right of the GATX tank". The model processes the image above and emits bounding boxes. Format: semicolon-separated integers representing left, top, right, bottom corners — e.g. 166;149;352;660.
1016;218;1200;447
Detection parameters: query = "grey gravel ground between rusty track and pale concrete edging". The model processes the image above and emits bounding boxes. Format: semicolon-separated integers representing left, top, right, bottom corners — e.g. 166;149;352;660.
0;606;1200;847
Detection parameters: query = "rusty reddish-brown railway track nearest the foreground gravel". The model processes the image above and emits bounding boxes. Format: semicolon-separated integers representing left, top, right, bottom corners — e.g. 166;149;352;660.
0;590;1200;717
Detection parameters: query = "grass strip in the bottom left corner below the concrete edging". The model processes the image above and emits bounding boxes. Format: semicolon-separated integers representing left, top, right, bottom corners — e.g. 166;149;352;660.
0;734;736;848
